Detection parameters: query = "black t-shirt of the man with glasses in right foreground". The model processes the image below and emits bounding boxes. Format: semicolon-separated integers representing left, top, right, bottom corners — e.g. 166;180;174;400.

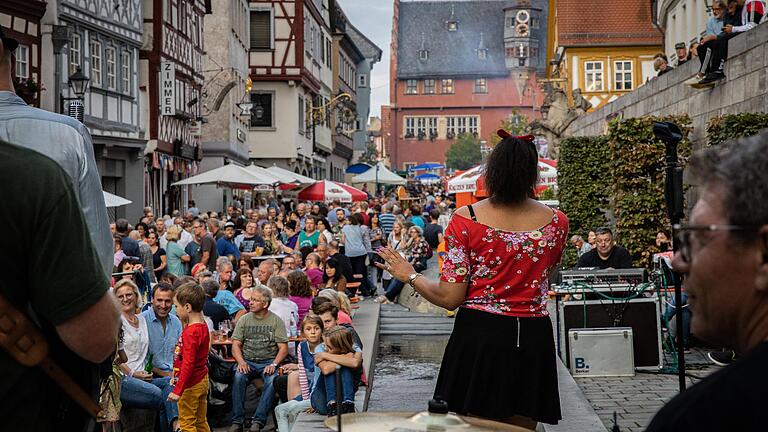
646;342;768;432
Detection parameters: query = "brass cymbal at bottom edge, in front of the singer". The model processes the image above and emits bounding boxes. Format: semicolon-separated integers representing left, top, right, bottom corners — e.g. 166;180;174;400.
325;411;532;432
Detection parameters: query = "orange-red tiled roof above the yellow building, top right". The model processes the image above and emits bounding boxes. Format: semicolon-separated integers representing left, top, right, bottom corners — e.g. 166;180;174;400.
557;0;662;46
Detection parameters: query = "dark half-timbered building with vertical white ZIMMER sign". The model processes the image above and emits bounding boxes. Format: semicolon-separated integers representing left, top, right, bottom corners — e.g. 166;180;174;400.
140;0;211;213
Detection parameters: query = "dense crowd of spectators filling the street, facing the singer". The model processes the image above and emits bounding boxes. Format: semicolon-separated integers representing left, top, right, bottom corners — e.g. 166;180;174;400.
106;190;453;432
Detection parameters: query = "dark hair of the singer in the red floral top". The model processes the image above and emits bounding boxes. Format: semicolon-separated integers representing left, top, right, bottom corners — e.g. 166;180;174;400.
485;136;539;204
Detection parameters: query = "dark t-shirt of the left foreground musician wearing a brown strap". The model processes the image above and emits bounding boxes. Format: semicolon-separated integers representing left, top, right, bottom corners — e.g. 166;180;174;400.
0;142;109;431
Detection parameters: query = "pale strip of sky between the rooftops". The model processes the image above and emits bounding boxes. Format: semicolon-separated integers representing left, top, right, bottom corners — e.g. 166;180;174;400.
336;0;394;117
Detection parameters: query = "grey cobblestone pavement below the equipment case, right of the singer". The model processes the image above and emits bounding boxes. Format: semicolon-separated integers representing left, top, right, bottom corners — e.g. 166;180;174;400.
576;350;718;432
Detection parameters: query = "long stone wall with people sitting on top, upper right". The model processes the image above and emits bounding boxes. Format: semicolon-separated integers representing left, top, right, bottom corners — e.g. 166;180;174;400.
571;23;768;147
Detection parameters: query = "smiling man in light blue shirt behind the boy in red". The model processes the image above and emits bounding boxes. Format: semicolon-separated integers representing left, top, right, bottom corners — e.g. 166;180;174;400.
142;282;182;432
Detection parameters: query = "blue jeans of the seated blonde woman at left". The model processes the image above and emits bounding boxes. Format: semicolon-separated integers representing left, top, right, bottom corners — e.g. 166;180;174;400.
120;376;179;432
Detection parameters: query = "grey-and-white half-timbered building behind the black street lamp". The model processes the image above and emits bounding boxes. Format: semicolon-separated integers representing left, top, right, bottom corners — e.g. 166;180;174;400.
42;0;146;219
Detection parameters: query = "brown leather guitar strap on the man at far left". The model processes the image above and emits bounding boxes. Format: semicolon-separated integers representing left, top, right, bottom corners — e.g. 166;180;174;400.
0;295;105;419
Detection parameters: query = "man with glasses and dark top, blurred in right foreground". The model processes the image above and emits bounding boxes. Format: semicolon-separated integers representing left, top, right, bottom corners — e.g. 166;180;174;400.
647;133;768;432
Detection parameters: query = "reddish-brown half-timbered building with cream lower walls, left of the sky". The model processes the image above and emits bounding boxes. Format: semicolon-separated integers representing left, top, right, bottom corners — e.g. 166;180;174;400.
247;0;333;179
